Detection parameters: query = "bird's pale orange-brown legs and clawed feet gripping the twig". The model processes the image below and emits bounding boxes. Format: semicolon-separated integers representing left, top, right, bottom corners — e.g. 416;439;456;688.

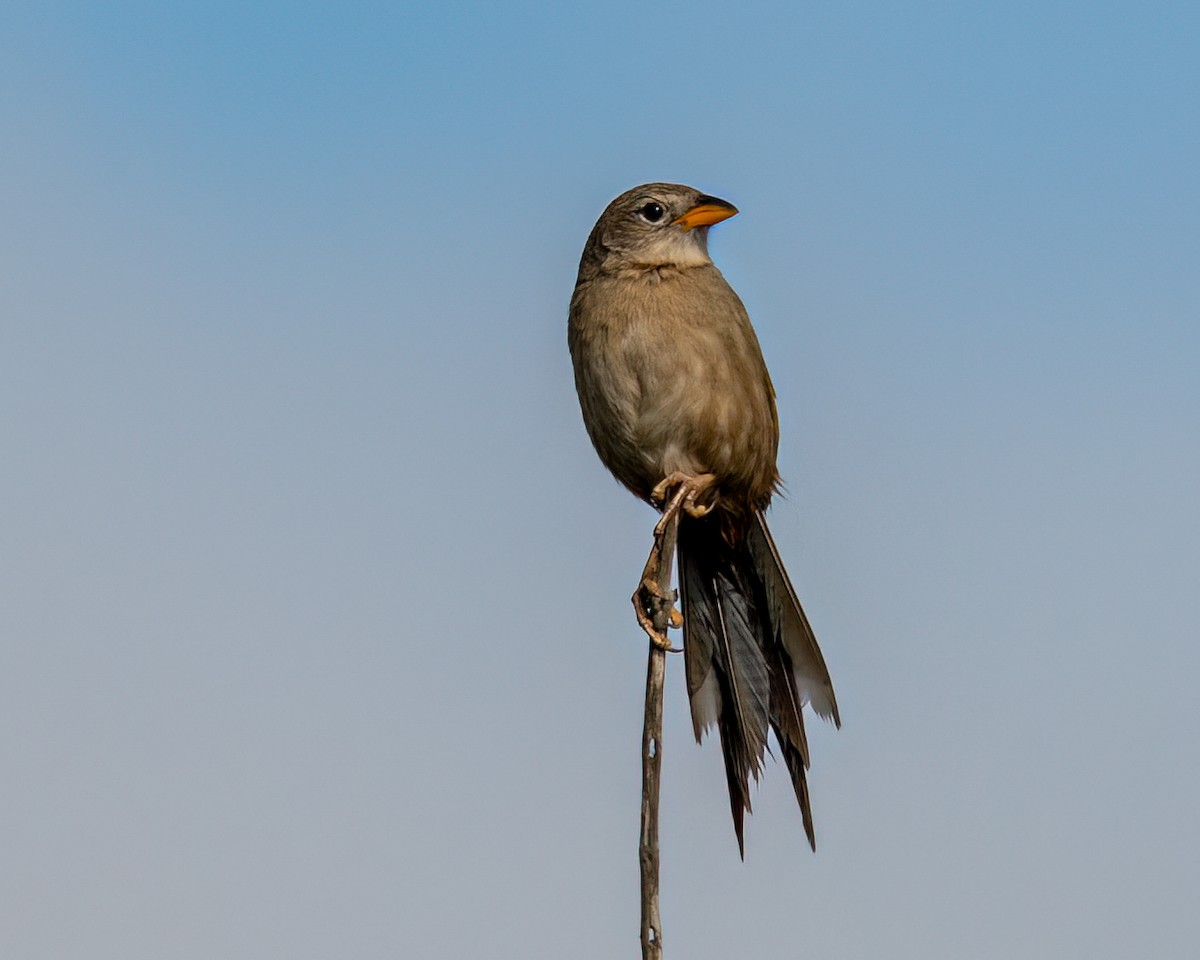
632;472;716;653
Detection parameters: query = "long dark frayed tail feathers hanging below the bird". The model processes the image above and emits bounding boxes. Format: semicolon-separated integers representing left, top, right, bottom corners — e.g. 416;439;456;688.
678;515;840;856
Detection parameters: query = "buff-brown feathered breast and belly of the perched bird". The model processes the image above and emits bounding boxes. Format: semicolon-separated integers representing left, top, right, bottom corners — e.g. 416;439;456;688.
570;266;779;505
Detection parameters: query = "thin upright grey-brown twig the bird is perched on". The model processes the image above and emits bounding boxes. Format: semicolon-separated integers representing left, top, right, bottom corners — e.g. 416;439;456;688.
637;514;679;960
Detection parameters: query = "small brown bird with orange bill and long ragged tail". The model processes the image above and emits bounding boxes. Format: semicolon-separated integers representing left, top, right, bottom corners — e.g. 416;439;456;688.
568;184;841;853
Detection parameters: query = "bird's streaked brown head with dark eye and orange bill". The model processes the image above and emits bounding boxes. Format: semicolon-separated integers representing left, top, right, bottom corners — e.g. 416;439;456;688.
583;184;738;276
